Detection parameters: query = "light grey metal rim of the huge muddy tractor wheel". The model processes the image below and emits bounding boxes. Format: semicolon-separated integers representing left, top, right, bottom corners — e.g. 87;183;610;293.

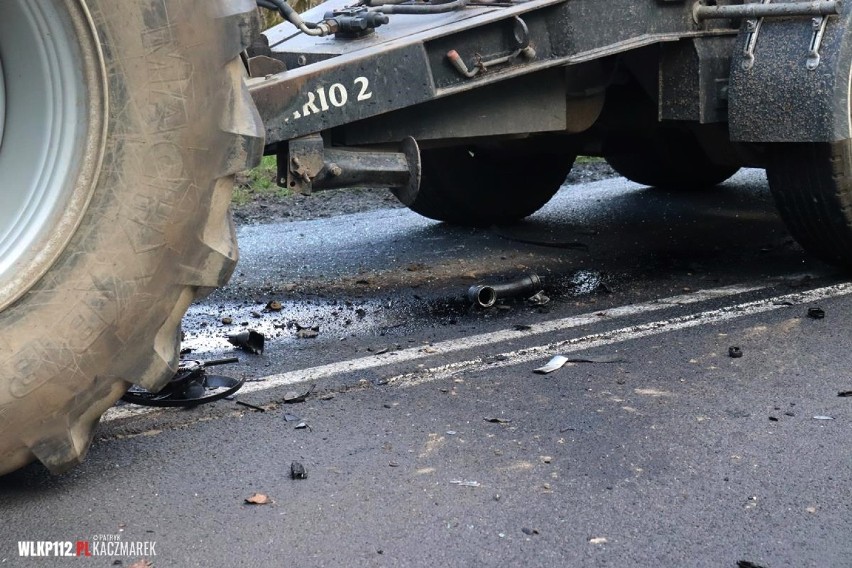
0;0;106;309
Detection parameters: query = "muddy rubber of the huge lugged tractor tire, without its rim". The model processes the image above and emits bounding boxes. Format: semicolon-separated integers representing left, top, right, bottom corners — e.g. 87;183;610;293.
0;0;263;473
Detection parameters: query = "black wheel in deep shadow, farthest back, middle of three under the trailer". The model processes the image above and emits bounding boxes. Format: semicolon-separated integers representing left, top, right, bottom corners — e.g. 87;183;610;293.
606;130;739;190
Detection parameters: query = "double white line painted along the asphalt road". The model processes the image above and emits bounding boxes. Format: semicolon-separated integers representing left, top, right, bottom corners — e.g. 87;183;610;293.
101;284;820;422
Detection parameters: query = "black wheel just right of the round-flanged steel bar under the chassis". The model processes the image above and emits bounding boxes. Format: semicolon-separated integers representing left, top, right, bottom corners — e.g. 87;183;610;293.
402;147;574;227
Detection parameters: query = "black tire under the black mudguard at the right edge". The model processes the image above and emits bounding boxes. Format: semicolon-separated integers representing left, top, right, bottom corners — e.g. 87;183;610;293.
766;140;852;267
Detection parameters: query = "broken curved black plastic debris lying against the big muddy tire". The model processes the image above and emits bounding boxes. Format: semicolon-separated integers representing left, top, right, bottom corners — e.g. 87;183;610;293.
121;357;245;407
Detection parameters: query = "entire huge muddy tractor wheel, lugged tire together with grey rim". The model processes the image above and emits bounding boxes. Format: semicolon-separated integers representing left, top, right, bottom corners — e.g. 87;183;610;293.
0;0;263;473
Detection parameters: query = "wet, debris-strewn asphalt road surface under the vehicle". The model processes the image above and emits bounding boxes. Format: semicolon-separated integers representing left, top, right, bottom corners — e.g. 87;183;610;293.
0;171;852;568
